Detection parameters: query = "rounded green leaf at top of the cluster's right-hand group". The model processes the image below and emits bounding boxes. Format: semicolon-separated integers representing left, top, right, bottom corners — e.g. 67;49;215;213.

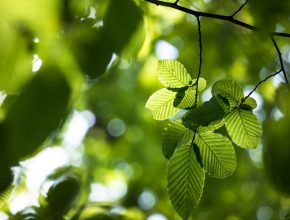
211;80;244;108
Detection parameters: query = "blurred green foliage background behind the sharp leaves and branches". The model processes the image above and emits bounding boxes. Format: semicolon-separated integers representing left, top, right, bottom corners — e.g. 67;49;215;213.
0;0;290;220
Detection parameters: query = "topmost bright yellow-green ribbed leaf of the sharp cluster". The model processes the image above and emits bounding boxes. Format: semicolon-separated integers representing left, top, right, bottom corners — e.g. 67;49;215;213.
157;60;192;88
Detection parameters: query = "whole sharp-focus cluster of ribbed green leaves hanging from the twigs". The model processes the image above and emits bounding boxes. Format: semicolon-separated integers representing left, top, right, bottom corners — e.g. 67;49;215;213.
146;60;262;219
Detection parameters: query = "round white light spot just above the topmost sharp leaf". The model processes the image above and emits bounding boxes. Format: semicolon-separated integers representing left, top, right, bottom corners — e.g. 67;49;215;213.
155;40;179;60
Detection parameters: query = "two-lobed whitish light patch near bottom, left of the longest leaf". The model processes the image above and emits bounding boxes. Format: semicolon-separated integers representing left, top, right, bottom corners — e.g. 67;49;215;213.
89;179;128;202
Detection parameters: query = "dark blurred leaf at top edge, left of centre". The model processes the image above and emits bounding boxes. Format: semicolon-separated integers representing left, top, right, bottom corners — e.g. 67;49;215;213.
72;0;142;79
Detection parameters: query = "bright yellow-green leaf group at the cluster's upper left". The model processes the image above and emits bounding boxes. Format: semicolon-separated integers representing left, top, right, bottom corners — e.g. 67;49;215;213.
146;60;206;120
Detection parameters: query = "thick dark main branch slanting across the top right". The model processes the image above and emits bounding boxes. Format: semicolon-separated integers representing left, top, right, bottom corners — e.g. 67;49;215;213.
144;0;290;38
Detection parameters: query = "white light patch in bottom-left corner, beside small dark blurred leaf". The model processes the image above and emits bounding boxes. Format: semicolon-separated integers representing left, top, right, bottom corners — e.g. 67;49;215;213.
9;192;39;214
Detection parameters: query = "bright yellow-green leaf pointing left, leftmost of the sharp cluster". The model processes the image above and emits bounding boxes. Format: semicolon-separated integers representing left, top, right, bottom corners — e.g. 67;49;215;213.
145;88;179;120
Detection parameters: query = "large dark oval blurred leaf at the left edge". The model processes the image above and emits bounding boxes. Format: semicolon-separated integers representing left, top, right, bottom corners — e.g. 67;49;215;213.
0;67;70;190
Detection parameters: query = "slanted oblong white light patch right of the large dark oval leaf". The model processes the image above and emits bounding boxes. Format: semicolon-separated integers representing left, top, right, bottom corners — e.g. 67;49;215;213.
63;110;96;148
